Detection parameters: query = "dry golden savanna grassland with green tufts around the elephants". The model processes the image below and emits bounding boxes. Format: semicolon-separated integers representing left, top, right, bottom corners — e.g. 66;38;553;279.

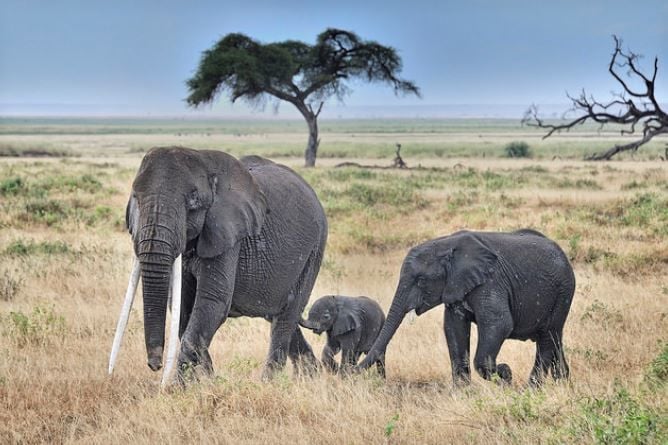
0;119;668;444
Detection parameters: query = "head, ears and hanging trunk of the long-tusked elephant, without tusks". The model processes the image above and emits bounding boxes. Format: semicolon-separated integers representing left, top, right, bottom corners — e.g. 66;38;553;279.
112;147;266;371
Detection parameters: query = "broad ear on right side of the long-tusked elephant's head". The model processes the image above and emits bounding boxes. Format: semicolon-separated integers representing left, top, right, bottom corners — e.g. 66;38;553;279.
197;153;267;258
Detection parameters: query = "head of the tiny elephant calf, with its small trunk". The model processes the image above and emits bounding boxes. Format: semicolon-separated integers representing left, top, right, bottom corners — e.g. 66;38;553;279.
299;295;360;337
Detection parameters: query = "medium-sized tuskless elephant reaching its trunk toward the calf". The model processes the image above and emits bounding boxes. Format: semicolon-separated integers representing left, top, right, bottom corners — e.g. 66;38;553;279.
359;229;575;385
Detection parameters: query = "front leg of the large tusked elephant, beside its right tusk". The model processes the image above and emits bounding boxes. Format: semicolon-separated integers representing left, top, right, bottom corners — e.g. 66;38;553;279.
179;250;236;381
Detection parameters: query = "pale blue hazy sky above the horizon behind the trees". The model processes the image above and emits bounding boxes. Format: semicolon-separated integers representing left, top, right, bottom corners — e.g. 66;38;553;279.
0;0;668;118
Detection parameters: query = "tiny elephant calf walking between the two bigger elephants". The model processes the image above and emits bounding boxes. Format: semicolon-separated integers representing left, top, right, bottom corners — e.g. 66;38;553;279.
299;295;385;377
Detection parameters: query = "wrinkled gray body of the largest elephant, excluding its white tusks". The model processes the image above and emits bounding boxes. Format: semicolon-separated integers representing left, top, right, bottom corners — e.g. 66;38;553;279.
126;147;327;377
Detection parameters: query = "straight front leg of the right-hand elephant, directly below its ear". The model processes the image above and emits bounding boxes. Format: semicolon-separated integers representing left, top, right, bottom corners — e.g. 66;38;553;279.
443;307;471;385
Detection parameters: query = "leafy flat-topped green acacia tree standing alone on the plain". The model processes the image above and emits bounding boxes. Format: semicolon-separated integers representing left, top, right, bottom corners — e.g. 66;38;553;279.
186;28;420;167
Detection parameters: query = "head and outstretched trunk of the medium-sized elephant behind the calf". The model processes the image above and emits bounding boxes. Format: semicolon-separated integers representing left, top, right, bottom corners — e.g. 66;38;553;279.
359;231;497;368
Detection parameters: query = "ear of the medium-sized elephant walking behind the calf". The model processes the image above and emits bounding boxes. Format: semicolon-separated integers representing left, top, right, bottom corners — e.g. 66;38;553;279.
441;233;497;305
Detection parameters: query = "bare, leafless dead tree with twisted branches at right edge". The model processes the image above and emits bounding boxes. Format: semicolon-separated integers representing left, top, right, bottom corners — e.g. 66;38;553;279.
522;36;668;160
